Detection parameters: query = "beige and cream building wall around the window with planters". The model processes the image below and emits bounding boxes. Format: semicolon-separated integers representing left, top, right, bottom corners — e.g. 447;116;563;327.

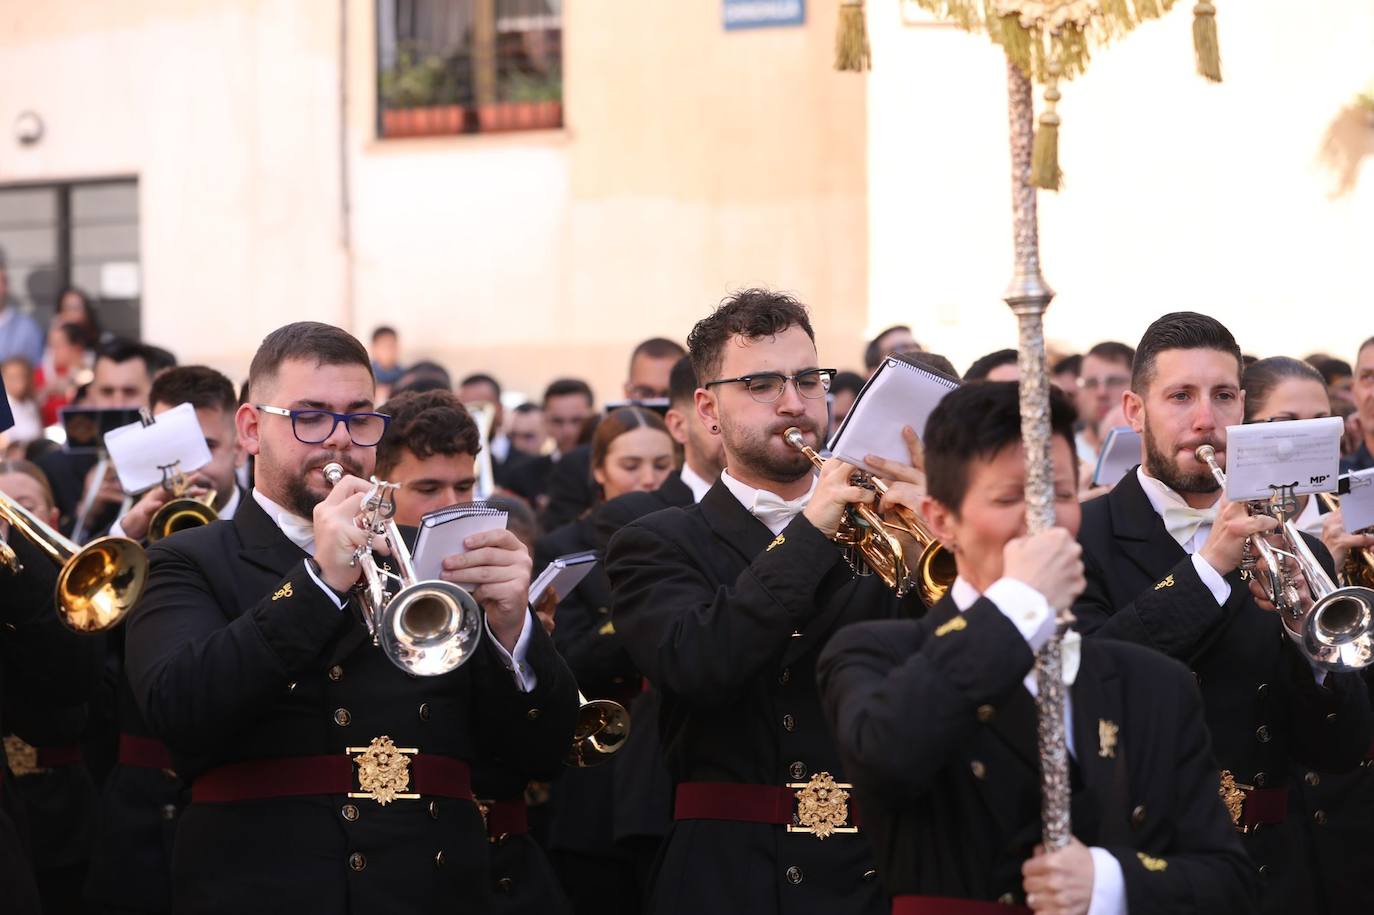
0;0;867;397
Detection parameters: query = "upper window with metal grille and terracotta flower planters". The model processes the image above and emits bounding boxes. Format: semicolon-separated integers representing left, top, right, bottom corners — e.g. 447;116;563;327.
376;0;563;137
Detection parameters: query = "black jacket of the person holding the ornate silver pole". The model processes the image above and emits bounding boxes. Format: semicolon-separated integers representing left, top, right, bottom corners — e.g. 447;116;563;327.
819;596;1254;915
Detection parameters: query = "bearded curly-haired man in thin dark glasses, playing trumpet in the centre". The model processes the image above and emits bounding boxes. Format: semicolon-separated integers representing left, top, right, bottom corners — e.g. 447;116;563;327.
606;290;923;915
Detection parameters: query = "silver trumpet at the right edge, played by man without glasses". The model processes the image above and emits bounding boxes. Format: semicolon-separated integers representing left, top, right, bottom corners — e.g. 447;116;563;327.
1194;445;1374;670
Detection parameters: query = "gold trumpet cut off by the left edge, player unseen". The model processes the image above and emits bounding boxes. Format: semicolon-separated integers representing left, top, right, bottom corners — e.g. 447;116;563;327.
0;493;148;632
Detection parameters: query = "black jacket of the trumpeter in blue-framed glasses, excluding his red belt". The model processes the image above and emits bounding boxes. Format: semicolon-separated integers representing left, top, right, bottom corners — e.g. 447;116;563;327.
128;499;577;912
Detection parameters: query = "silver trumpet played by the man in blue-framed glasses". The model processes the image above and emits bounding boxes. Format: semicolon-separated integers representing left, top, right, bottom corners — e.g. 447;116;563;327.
324;462;482;677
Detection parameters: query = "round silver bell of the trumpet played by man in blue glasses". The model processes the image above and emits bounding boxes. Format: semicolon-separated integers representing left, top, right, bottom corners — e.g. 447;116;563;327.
376;581;482;677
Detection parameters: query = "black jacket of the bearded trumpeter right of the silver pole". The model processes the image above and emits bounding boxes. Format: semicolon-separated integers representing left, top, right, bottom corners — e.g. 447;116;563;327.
1073;471;1371;912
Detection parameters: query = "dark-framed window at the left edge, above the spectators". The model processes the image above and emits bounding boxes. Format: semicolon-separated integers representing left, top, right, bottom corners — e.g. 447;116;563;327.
0;180;143;339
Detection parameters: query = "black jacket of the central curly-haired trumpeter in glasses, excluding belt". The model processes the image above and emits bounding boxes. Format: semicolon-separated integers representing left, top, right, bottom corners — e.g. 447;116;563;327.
607;482;923;915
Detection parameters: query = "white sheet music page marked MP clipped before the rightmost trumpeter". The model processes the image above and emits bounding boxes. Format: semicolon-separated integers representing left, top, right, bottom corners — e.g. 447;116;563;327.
1226;416;1345;501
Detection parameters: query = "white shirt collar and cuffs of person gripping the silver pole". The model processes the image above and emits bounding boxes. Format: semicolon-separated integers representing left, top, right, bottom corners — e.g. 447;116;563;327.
949;577;1127;915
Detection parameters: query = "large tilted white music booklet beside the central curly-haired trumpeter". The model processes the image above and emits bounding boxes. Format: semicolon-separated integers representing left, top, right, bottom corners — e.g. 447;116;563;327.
830;359;959;473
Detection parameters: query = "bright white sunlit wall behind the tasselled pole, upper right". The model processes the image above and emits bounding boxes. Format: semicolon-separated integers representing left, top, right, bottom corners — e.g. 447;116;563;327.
868;0;1374;370
